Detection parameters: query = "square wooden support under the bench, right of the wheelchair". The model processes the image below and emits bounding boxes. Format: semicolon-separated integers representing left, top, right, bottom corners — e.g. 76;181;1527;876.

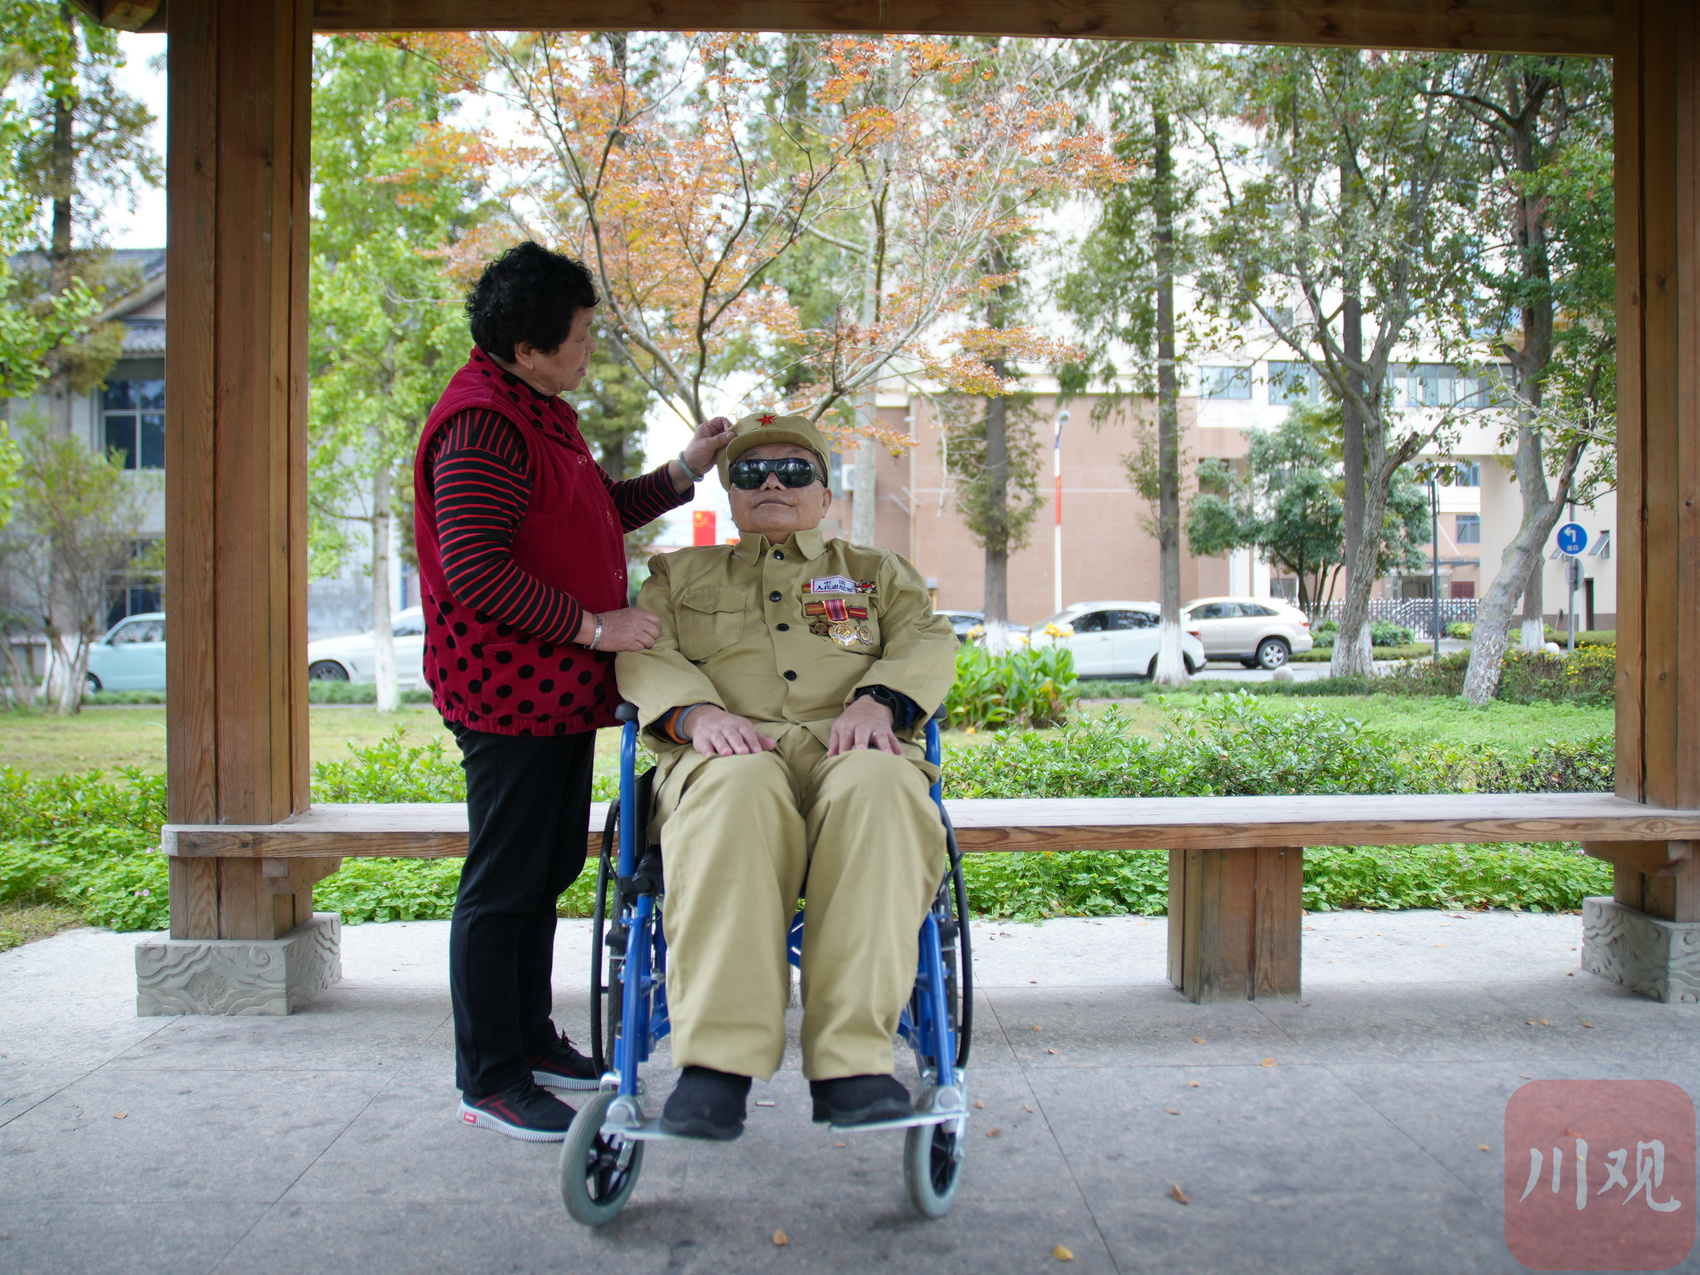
1170;847;1304;1005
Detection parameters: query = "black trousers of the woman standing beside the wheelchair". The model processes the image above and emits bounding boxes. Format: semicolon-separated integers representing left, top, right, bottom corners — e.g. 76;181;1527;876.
449;726;597;1098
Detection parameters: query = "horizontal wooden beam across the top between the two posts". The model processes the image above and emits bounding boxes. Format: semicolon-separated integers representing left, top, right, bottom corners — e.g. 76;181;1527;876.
313;0;1613;56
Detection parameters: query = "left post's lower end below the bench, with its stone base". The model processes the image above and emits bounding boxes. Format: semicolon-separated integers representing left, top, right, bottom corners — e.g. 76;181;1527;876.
136;857;342;1017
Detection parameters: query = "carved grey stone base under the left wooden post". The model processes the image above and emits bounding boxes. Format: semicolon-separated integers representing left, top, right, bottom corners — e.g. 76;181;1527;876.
136;911;342;1018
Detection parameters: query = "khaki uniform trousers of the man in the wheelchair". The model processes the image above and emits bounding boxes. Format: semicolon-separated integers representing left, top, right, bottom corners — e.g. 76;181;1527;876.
661;728;949;1080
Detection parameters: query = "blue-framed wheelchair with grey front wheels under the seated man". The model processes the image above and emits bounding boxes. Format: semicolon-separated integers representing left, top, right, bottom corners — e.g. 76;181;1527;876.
561;704;974;1226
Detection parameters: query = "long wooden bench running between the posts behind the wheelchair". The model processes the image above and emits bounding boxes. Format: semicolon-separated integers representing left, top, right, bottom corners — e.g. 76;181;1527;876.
163;792;1700;1001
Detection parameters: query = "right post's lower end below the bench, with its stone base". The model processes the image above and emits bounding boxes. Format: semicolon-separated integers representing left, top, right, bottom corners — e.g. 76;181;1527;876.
1583;842;1700;1005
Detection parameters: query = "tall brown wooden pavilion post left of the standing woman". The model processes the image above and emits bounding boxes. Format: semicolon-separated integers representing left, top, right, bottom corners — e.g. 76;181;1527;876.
138;0;338;1012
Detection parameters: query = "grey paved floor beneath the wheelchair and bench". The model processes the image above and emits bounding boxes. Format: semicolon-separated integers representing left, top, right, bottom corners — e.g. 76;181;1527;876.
0;911;1700;1275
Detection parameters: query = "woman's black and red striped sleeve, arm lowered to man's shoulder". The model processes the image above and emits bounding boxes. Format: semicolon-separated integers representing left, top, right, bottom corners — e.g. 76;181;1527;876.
427;411;584;643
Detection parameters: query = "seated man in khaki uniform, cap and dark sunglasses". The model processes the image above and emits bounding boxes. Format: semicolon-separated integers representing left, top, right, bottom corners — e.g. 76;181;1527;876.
617;413;957;1141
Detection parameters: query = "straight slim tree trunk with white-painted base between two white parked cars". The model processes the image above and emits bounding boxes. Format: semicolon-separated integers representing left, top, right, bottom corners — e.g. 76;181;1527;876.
1151;104;1192;687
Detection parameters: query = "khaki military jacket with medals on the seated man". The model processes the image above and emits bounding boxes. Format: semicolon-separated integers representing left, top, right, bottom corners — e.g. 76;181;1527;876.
615;529;957;821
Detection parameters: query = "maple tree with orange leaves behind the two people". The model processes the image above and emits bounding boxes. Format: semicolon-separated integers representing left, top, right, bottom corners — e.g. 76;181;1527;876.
389;32;1127;469
